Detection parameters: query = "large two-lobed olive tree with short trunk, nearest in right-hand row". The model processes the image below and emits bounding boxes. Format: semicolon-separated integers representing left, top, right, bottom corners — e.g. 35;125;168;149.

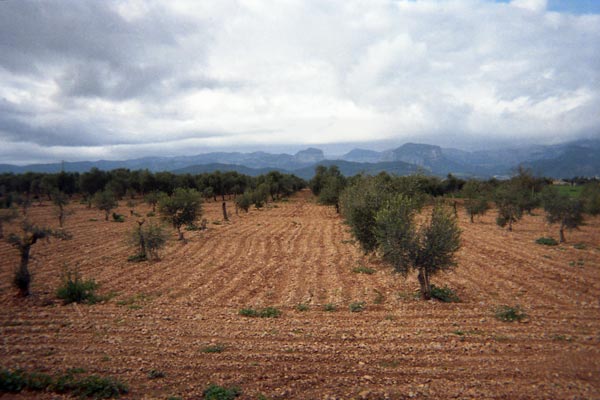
375;195;460;300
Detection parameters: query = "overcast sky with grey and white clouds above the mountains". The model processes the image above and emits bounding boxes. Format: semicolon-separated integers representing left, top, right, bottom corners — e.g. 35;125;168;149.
0;0;600;164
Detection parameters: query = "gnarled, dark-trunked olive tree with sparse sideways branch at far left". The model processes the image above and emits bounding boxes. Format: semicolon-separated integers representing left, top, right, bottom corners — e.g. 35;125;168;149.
7;220;71;296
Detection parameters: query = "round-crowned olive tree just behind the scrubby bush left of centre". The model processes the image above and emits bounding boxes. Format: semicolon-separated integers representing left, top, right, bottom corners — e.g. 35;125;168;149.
158;188;202;240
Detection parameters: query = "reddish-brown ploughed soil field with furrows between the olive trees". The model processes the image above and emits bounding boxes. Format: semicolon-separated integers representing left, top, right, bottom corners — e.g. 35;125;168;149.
0;192;600;399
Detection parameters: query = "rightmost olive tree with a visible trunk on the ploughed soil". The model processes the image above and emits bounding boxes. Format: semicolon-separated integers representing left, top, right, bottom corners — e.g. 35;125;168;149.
542;186;583;243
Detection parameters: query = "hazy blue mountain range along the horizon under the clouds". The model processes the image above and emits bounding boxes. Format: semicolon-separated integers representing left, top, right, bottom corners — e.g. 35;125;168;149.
0;139;600;179
